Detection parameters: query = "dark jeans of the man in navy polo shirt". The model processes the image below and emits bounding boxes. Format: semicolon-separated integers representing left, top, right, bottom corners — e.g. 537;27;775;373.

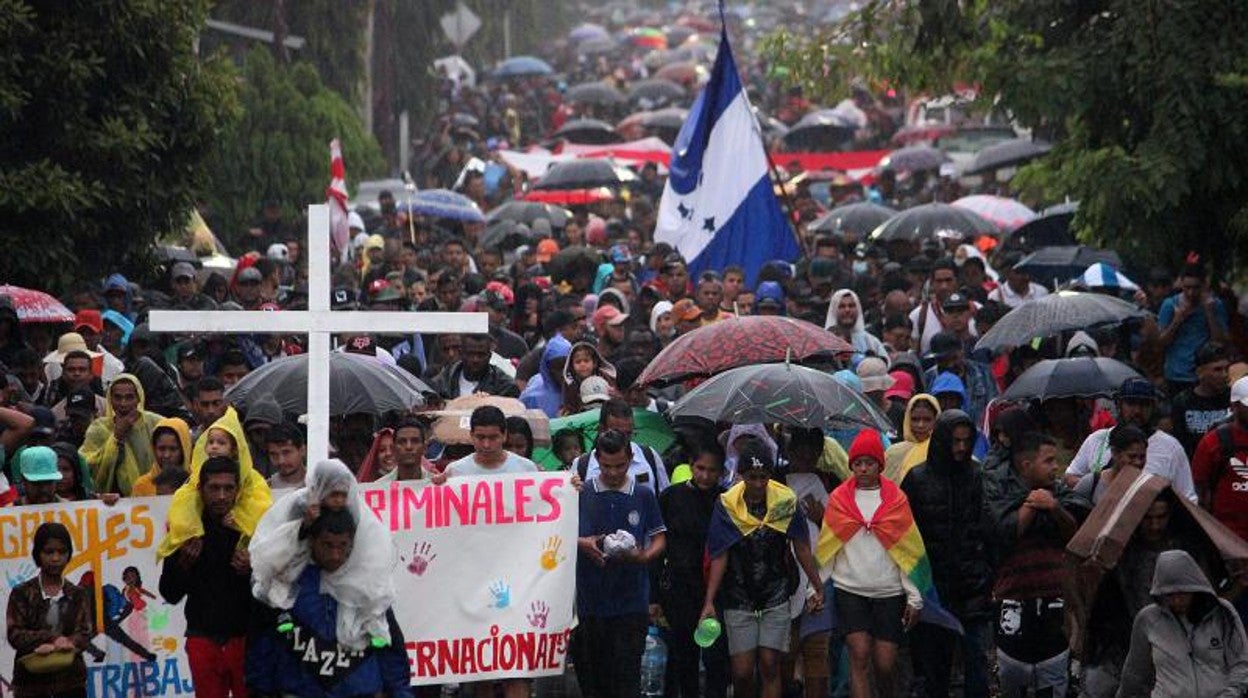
573;613;650;698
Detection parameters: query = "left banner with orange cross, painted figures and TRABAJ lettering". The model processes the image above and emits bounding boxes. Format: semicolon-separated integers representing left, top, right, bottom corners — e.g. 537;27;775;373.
0;497;195;698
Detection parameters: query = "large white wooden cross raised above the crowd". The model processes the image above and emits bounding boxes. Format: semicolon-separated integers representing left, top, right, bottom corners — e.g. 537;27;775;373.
147;204;489;465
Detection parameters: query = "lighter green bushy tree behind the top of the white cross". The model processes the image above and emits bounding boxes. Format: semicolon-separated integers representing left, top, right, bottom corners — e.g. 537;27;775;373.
203;49;386;246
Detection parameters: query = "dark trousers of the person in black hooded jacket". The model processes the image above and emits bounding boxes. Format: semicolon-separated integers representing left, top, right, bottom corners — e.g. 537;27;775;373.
910;619;992;698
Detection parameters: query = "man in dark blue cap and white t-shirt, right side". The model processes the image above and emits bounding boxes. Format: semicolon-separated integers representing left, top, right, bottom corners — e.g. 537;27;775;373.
1066;378;1197;502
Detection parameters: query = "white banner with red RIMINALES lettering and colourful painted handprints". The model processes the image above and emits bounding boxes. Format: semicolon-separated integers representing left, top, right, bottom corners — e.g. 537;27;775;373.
362;472;579;684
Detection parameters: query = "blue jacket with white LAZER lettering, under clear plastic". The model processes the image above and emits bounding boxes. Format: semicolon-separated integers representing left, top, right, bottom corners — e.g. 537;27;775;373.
246;564;412;698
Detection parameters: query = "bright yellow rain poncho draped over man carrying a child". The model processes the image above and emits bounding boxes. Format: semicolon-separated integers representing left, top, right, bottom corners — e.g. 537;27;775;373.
156;407;273;559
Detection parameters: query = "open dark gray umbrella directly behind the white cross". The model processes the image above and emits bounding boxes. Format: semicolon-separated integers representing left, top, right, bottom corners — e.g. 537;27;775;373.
226;352;433;415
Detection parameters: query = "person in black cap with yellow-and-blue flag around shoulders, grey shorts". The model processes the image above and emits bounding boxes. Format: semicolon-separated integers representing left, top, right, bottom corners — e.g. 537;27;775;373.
701;437;824;697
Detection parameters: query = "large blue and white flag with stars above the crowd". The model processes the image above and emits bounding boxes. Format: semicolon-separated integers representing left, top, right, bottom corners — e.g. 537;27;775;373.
654;25;800;286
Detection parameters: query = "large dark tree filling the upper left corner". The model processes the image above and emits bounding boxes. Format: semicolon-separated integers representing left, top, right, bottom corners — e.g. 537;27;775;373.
0;0;237;290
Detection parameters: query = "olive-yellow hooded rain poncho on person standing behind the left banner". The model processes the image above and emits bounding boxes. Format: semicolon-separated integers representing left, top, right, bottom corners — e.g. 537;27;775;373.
79;373;160;497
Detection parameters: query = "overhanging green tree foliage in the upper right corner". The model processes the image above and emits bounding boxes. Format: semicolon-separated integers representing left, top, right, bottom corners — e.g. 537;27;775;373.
769;0;1248;270
